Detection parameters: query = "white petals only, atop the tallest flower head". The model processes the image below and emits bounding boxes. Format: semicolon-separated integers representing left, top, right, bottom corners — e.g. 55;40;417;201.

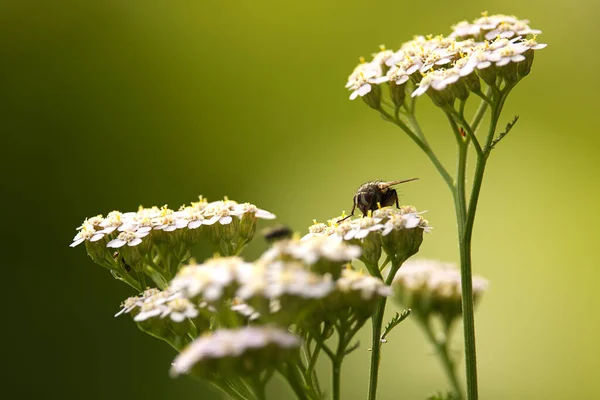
346;15;546;100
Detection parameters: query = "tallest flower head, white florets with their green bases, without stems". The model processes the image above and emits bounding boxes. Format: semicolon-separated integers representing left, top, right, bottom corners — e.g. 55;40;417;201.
346;14;546;109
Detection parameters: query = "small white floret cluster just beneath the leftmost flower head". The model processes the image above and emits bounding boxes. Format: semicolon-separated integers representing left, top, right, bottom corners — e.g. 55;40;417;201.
115;289;198;322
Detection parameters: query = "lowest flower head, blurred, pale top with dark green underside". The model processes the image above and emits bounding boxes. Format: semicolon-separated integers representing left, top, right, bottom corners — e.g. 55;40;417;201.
171;326;302;379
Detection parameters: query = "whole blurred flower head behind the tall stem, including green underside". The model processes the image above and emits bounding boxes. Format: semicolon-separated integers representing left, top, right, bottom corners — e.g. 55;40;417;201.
392;260;488;326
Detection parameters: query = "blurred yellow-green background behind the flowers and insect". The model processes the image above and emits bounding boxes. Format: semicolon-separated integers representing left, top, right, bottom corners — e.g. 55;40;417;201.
5;0;600;400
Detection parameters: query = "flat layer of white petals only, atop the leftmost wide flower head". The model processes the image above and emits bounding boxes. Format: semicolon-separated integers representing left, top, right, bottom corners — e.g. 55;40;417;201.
71;197;275;248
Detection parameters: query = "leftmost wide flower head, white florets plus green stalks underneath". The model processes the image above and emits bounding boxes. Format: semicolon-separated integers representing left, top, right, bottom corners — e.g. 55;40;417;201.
71;196;275;290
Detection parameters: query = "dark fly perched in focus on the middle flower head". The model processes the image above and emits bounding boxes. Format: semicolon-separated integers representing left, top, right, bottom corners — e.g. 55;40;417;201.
339;178;419;222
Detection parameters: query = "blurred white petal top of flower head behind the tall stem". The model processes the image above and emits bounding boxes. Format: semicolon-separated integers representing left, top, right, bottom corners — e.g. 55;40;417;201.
392;260;488;301
